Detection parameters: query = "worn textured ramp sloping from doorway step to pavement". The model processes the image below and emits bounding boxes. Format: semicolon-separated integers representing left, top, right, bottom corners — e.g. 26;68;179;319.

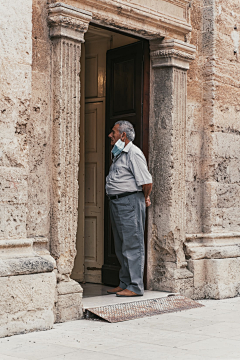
85;295;204;323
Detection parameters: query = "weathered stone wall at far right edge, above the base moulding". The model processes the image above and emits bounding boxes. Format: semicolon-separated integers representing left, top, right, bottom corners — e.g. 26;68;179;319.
210;0;240;232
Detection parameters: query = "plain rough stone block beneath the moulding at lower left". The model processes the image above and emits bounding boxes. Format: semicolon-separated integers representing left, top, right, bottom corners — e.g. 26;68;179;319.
0;273;56;337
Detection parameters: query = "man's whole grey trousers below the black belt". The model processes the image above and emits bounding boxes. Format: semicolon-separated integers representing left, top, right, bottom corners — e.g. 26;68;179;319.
110;192;146;295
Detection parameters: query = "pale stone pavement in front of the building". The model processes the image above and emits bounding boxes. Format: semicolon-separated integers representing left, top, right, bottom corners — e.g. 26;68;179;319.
0;297;240;360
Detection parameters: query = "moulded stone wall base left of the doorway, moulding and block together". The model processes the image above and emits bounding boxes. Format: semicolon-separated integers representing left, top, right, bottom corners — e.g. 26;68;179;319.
0;239;56;337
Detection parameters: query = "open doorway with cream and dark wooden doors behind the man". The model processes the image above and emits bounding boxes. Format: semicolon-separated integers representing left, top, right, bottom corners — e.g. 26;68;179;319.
72;25;149;292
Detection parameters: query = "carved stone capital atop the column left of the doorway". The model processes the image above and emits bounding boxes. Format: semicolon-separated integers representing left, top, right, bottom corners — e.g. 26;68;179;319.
48;3;92;42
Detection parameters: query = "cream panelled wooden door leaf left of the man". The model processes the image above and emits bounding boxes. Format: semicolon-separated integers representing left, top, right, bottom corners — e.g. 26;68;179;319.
84;101;105;283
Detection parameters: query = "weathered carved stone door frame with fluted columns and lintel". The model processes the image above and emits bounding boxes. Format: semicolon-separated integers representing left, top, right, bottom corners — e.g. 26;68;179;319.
48;0;196;321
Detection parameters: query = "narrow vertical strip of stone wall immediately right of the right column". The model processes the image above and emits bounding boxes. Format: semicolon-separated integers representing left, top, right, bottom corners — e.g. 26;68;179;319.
186;0;203;234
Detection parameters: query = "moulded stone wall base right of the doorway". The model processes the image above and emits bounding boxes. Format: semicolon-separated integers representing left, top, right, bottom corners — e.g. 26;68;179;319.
185;233;240;300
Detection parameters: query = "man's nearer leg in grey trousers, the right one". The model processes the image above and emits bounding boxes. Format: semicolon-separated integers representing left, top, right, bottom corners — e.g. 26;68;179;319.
116;192;146;295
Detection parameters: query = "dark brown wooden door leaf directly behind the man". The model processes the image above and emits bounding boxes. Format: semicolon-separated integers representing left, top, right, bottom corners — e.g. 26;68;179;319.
102;41;149;286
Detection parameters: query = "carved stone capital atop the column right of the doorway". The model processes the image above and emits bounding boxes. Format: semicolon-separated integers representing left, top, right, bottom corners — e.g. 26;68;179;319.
150;39;196;70
